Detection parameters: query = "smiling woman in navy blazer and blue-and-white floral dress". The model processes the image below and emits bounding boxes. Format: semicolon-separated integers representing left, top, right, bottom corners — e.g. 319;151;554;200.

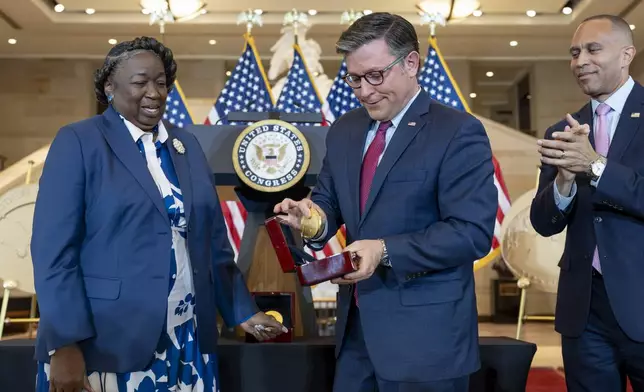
31;37;285;392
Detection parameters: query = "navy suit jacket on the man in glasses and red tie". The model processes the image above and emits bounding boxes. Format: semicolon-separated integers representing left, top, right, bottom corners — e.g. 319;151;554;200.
312;91;498;382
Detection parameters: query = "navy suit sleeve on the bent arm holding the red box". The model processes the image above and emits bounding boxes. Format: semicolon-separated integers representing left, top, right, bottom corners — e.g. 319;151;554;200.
384;119;498;281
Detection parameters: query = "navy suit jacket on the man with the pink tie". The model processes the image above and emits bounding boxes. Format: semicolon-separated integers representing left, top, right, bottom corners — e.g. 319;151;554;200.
530;82;644;342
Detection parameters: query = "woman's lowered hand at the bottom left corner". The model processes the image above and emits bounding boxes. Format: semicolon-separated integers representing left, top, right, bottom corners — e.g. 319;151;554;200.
49;344;94;392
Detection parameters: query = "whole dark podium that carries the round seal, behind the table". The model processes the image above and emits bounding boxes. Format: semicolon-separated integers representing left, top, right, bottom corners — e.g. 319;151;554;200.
184;113;328;338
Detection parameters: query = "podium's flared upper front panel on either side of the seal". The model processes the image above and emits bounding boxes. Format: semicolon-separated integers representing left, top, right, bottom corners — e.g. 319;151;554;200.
183;125;329;187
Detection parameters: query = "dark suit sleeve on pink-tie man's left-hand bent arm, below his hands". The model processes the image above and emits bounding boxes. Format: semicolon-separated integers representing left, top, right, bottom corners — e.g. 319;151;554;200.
530;128;577;237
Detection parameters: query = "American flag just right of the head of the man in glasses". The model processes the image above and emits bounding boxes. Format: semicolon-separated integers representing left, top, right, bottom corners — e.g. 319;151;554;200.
419;38;510;269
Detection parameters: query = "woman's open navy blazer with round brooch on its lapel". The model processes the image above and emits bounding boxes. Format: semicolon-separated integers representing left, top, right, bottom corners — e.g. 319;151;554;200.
31;107;257;372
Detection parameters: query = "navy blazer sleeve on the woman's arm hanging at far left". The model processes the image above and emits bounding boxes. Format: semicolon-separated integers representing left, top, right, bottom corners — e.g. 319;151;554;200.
31;127;96;351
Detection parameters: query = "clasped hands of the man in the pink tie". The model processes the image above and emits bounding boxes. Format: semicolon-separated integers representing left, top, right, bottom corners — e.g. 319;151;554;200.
537;114;599;182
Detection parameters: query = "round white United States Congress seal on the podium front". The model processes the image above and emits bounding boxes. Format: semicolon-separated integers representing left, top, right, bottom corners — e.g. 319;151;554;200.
233;120;311;192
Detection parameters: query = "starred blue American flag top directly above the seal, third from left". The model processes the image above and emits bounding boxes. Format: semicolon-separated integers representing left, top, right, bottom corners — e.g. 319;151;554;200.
277;44;322;125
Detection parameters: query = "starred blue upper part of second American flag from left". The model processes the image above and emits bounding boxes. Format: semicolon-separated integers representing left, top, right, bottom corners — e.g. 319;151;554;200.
204;35;274;125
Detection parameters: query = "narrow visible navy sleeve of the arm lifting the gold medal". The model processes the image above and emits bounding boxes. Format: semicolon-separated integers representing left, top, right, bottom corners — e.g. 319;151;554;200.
307;126;344;250
